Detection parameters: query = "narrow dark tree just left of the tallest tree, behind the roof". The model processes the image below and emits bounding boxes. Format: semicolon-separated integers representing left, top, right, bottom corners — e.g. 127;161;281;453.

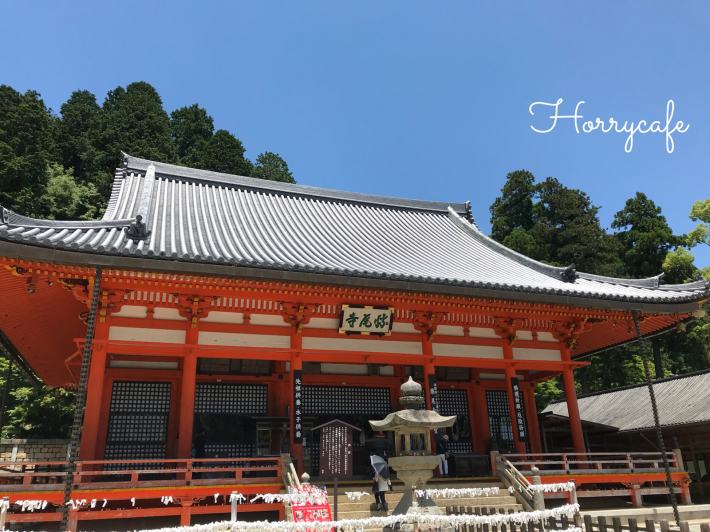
56;91;101;183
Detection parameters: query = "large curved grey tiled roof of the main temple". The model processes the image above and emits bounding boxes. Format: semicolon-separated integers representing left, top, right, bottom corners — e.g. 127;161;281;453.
0;152;710;303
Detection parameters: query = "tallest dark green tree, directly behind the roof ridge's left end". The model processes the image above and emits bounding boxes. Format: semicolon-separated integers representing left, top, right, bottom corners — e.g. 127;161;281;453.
81;81;177;201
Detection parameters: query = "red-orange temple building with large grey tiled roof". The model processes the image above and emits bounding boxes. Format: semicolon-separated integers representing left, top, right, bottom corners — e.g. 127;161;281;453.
0;155;710;524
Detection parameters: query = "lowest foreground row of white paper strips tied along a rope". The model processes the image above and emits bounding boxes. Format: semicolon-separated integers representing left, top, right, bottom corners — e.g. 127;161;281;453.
110;504;581;532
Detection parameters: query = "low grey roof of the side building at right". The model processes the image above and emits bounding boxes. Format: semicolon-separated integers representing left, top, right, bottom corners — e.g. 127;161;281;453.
542;371;710;431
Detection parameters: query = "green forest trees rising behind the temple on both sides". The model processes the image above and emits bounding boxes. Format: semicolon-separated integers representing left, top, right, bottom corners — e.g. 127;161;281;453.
0;82;710;438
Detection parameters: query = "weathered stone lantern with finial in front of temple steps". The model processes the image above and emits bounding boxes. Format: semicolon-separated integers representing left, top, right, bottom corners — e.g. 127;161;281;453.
370;377;456;515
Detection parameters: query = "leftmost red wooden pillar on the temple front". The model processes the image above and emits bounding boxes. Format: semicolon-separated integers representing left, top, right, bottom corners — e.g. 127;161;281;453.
79;317;109;460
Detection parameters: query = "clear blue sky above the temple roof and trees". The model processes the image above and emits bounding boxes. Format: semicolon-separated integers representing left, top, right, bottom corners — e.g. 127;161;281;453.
0;0;710;265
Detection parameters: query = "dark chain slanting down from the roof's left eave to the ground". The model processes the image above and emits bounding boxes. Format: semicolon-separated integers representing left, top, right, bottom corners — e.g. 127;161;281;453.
59;267;102;531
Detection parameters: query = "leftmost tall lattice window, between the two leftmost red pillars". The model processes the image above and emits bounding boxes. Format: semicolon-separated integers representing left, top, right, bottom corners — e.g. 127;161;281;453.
104;381;171;471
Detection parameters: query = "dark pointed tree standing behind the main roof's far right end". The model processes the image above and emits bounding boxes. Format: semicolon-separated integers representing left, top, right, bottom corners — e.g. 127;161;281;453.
611;192;685;279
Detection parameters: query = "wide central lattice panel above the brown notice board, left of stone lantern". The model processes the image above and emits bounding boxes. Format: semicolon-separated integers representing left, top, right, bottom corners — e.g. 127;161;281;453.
302;386;390;416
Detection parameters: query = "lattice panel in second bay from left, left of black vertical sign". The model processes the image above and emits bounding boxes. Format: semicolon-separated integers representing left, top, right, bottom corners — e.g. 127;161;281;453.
195;383;268;416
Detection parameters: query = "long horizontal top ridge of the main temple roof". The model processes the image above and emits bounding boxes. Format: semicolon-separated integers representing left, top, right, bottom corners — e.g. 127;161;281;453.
115;152;467;215
